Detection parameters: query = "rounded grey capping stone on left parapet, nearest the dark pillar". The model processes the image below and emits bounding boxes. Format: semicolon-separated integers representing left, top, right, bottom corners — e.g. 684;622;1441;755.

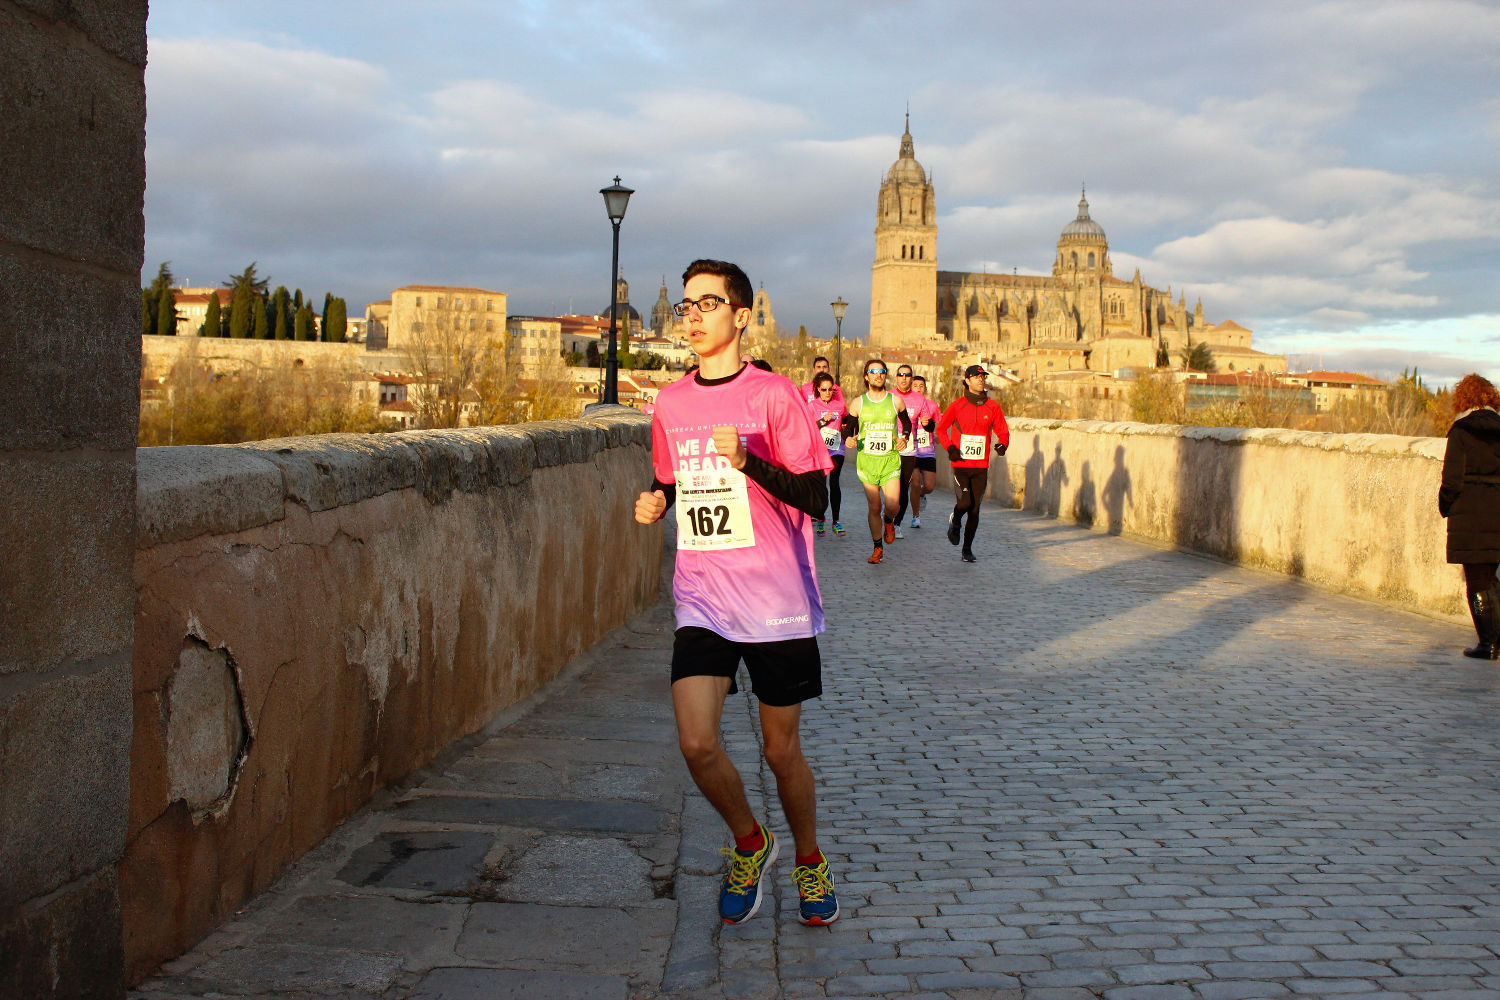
135;445;287;547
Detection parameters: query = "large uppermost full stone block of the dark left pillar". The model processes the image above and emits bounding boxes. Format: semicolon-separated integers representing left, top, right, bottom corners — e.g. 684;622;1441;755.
0;0;146;271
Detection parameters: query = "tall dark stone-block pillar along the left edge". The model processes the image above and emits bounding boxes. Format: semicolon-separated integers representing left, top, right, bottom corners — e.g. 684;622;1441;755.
0;0;146;1000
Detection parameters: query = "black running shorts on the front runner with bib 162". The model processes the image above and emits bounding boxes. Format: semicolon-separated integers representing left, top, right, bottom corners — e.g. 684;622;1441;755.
672;625;824;708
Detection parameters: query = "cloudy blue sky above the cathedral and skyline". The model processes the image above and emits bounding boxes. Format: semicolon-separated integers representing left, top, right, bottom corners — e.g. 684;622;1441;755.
146;0;1500;382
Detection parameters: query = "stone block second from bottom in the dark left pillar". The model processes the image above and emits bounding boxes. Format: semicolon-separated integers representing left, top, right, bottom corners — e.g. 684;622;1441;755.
0;655;131;911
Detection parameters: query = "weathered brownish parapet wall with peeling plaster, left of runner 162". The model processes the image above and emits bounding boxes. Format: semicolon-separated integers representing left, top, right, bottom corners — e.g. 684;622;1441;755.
120;408;662;981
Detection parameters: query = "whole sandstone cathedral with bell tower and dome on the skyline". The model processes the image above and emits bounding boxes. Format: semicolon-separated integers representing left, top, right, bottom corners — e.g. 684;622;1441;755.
870;117;1286;378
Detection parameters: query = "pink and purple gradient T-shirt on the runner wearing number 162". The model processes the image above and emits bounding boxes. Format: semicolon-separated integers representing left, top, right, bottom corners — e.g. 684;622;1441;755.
651;366;833;642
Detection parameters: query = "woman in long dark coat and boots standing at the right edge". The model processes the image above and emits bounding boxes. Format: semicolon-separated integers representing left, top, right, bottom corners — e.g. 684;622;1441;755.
1437;375;1500;660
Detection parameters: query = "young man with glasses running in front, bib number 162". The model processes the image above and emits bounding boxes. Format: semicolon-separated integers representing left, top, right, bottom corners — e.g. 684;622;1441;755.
635;261;839;925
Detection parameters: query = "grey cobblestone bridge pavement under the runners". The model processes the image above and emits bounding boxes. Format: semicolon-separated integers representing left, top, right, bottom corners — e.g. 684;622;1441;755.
132;512;1500;1000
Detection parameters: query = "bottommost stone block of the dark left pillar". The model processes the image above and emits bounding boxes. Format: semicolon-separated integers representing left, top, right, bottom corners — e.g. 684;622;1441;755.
0;868;122;1000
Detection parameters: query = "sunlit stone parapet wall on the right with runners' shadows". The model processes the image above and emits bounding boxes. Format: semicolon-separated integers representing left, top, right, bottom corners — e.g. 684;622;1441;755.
978;418;1467;621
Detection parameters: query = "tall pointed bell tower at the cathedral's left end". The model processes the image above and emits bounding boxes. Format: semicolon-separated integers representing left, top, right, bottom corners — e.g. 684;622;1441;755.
870;114;938;348
